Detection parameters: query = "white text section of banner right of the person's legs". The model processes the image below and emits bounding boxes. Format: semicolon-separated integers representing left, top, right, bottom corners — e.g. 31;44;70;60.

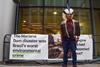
77;35;93;60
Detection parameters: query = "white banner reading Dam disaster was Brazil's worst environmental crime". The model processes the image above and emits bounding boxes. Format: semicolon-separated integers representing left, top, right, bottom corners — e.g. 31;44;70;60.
9;34;48;60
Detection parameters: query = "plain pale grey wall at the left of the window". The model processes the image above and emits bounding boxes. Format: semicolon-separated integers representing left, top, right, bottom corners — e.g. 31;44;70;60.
0;0;16;61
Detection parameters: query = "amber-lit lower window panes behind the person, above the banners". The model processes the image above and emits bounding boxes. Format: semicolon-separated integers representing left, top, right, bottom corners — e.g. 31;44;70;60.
18;8;91;34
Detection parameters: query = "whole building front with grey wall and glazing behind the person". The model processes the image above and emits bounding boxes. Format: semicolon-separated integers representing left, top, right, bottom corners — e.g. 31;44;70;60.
0;0;100;60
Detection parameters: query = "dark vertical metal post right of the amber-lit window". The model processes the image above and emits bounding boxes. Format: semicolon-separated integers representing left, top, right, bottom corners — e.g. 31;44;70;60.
89;0;96;58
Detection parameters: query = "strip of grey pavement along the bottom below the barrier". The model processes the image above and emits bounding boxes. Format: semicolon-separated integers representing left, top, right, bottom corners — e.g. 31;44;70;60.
0;64;100;67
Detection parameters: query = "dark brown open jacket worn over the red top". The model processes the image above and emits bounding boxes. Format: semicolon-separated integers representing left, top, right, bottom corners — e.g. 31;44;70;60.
61;20;80;40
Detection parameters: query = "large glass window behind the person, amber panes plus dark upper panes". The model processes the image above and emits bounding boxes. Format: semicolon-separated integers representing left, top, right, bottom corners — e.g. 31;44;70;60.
18;0;91;34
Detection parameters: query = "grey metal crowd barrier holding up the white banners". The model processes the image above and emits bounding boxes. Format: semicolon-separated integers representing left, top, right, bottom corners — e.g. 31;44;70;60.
3;34;100;64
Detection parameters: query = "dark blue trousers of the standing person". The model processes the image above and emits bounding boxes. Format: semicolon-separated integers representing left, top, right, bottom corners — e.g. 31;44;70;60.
62;39;77;65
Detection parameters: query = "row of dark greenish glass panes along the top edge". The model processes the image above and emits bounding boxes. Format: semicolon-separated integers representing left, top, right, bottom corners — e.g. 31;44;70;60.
15;0;89;8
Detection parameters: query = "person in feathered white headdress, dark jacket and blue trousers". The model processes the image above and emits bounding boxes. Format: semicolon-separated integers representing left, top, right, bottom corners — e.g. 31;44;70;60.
61;8;80;67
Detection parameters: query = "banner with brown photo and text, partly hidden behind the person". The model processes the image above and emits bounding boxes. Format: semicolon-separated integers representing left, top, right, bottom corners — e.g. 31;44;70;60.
49;34;93;60
